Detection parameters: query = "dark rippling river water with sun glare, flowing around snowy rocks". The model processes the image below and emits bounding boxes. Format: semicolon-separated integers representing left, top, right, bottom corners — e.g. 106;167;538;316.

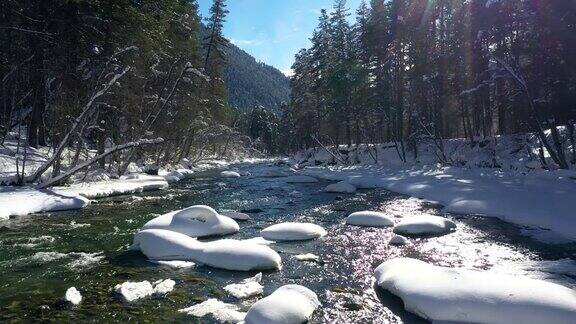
0;164;576;323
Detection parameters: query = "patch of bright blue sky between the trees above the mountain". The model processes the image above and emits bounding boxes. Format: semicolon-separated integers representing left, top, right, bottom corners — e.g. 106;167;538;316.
198;0;361;74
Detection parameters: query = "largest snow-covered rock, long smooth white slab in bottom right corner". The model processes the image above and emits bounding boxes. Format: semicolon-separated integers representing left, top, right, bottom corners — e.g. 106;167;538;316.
374;258;576;324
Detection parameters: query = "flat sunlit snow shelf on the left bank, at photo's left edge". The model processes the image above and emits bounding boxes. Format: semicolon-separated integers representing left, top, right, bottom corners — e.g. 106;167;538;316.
0;189;90;220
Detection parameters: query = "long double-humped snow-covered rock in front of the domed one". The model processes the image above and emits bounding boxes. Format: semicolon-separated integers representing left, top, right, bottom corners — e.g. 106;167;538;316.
134;229;282;271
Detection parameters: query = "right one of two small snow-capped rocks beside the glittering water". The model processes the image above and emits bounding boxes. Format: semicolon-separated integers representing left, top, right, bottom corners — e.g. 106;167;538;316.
394;215;456;235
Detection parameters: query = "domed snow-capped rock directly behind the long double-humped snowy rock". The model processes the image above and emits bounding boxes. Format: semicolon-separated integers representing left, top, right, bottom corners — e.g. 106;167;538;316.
142;205;240;237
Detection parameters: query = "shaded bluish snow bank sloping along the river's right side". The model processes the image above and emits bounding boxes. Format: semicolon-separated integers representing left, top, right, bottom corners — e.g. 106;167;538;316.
303;166;576;241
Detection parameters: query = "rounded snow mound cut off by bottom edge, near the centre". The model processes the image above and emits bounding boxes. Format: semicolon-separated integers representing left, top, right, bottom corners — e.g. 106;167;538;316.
245;285;321;324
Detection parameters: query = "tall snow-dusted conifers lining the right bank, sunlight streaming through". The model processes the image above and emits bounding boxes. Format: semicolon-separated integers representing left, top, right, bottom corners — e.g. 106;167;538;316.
282;0;576;168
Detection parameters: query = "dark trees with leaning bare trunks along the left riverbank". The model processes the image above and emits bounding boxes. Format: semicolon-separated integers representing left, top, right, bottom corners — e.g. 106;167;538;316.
0;0;243;182
